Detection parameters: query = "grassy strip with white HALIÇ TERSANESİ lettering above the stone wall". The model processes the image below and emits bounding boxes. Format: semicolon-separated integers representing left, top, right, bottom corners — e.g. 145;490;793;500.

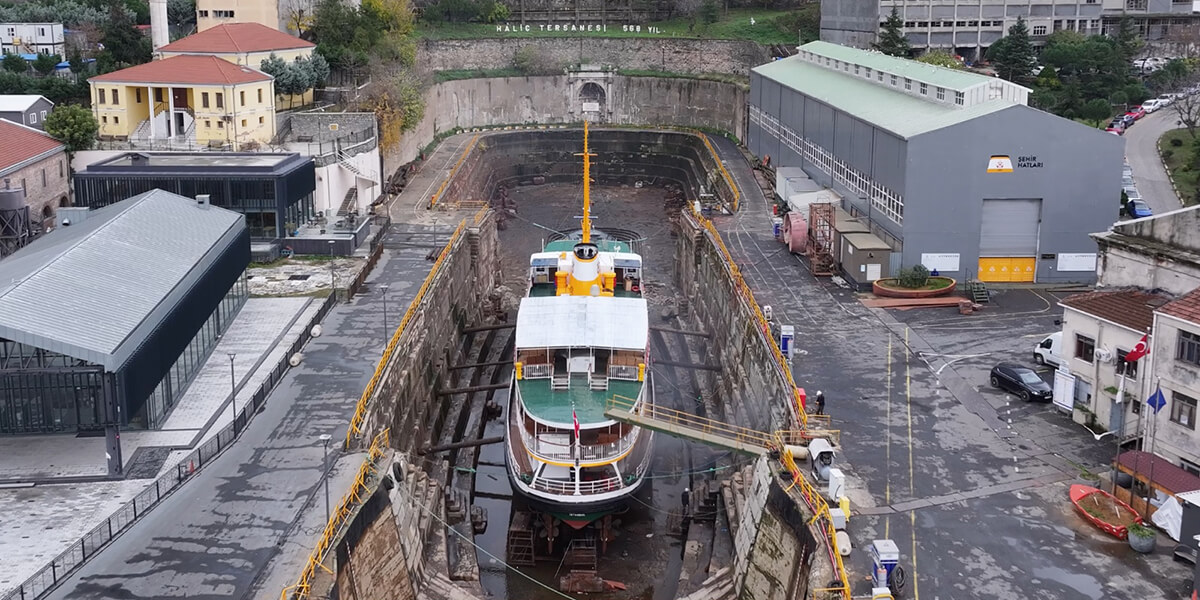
416;8;799;44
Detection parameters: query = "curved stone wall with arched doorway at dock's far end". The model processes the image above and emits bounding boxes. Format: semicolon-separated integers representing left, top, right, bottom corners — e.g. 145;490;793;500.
393;73;748;173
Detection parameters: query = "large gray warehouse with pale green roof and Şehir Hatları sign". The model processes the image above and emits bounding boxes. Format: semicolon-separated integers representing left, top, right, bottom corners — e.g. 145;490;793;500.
748;42;1124;283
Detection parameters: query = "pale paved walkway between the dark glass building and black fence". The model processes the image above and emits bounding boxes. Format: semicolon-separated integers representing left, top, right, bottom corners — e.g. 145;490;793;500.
0;298;320;593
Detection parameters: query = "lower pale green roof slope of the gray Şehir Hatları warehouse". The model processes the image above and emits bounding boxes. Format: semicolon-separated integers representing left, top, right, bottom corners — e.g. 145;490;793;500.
754;56;1021;138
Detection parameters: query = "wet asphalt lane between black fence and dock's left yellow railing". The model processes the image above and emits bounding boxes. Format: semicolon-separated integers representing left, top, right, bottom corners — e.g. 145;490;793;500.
48;224;450;599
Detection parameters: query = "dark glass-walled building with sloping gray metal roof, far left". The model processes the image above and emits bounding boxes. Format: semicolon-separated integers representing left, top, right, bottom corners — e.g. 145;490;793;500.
0;190;250;467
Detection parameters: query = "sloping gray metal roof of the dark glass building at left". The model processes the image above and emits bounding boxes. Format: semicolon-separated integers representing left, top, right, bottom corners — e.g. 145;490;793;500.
0;190;246;371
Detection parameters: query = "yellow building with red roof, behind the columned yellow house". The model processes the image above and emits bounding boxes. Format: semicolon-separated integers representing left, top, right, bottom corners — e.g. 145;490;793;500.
155;23;317;109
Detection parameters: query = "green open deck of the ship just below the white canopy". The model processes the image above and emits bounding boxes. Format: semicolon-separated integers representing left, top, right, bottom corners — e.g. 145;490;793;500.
517;377;642;426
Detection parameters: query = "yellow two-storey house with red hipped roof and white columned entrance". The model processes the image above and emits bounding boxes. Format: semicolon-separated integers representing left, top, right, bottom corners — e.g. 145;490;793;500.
89;54;276;150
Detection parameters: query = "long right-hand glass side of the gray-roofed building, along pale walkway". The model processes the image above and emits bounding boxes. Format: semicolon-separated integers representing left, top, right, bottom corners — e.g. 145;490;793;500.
137;275;250;428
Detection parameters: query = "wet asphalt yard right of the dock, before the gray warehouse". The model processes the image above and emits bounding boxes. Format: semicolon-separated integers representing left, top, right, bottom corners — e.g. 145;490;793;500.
714;138;1190;600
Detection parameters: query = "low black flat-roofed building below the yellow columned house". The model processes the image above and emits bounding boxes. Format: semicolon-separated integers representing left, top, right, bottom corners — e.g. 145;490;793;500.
74;152;317;241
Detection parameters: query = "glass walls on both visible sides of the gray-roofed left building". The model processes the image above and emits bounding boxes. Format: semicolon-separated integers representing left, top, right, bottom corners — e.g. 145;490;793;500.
0;275;250;433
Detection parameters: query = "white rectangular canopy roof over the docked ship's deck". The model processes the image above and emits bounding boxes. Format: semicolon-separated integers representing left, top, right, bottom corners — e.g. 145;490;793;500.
516;296;649;350
